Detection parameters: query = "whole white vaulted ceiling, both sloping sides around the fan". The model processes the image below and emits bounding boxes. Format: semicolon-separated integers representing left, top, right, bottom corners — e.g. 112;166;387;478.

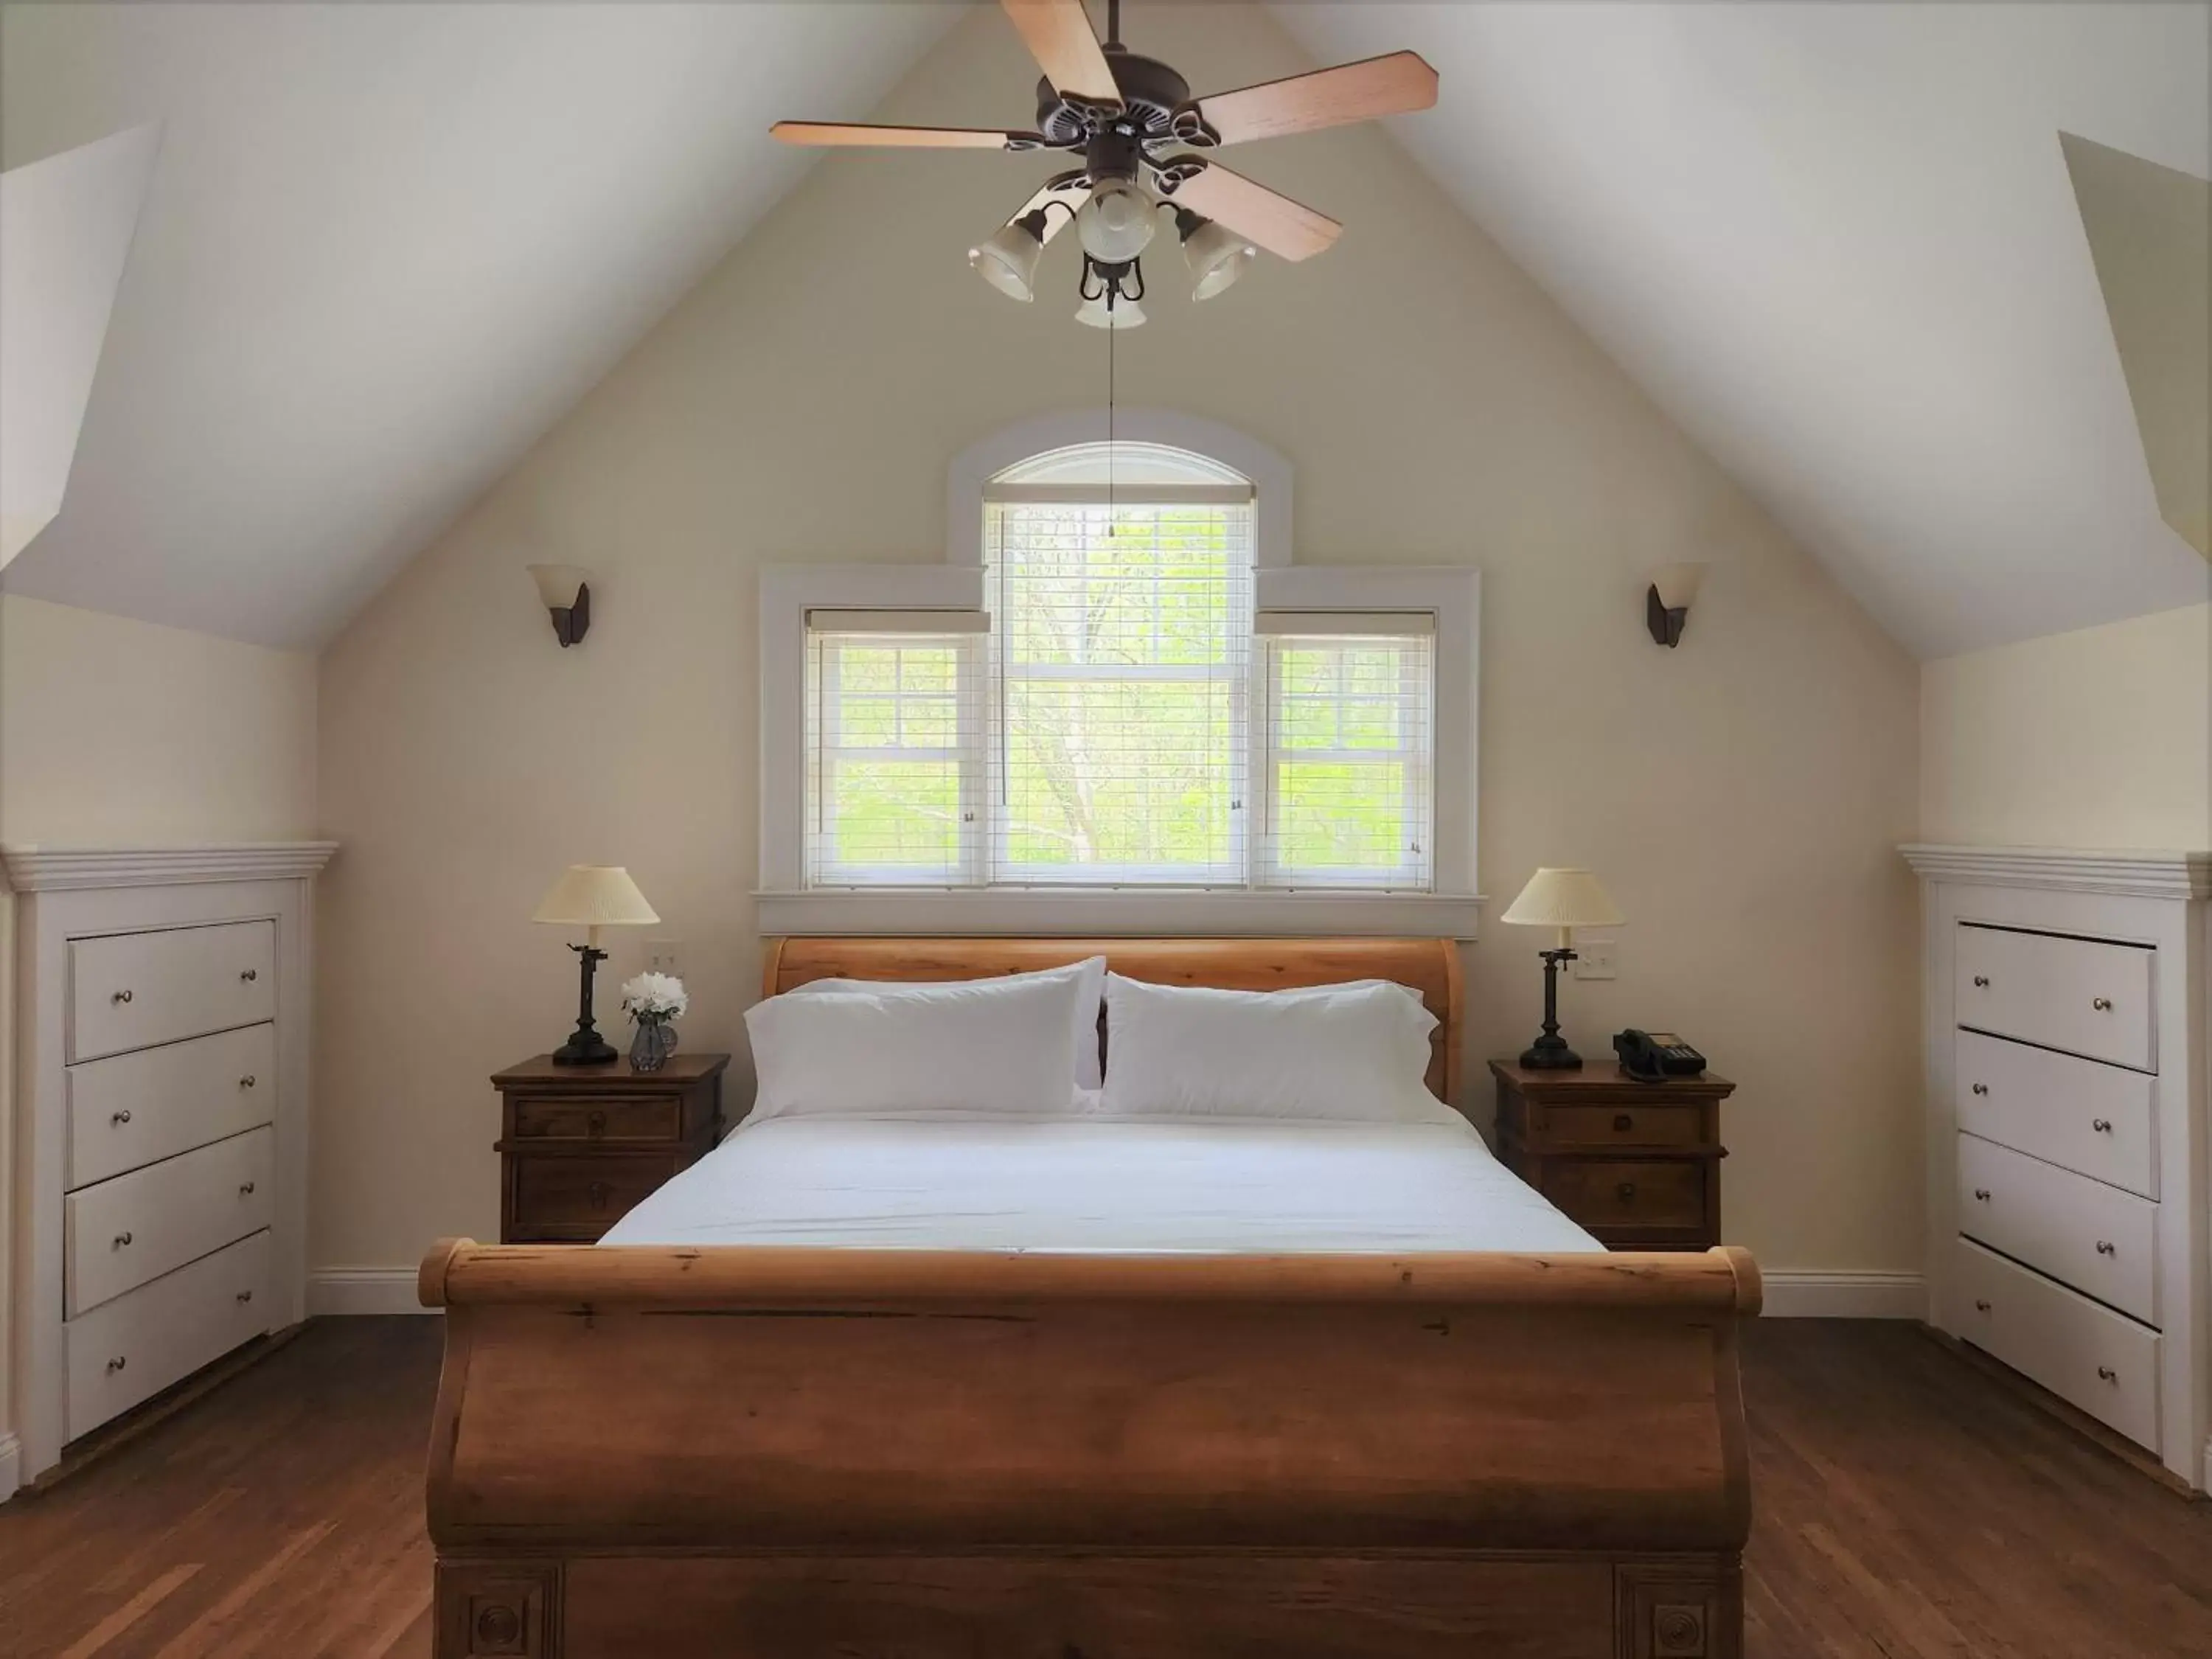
0;0;2212;655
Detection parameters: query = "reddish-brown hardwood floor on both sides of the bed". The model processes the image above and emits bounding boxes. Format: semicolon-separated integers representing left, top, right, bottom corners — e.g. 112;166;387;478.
0;1318;2212;1659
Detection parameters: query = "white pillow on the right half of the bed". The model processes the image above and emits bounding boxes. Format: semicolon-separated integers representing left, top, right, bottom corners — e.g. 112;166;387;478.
1097;973;1438;1124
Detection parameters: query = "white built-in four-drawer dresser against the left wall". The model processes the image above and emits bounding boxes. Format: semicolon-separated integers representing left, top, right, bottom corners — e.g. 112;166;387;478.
0;841;334;1480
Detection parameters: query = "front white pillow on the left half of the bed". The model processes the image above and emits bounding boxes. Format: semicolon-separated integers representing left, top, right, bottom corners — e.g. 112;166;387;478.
745;975;1077;1121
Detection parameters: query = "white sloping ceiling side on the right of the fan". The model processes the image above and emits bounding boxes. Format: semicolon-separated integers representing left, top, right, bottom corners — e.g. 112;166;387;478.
1276;0;2212;655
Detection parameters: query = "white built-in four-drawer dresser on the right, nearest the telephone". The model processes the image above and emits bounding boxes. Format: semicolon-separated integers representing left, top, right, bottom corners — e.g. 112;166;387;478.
1905;845;2212;1491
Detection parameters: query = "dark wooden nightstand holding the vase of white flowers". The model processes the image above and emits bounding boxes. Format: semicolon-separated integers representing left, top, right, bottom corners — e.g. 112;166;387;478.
491;1053;730;1243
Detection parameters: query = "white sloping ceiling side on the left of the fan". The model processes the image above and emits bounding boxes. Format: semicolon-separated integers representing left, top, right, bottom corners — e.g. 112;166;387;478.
0;2;958;646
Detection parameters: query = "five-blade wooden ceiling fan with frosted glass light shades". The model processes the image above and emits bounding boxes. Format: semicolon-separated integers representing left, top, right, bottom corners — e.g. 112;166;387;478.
772;0;1436;327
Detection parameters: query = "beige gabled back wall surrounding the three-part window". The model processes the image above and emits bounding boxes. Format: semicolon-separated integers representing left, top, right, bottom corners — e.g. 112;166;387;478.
314;7;1920;1270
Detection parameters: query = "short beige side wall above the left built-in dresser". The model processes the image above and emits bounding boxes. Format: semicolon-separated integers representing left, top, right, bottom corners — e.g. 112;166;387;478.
0;595;316;1478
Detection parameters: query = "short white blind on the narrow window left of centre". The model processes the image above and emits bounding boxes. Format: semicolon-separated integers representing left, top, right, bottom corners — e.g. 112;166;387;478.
805;611;989;887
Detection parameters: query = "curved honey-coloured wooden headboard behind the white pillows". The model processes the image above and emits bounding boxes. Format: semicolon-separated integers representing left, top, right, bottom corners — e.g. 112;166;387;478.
761;938;1460;1102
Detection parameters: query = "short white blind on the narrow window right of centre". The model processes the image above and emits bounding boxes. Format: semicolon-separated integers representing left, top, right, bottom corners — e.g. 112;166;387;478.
1254;613;1436;889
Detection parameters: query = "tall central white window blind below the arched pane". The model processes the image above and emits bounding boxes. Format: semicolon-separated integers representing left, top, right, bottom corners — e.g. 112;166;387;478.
984;498;1252;887
